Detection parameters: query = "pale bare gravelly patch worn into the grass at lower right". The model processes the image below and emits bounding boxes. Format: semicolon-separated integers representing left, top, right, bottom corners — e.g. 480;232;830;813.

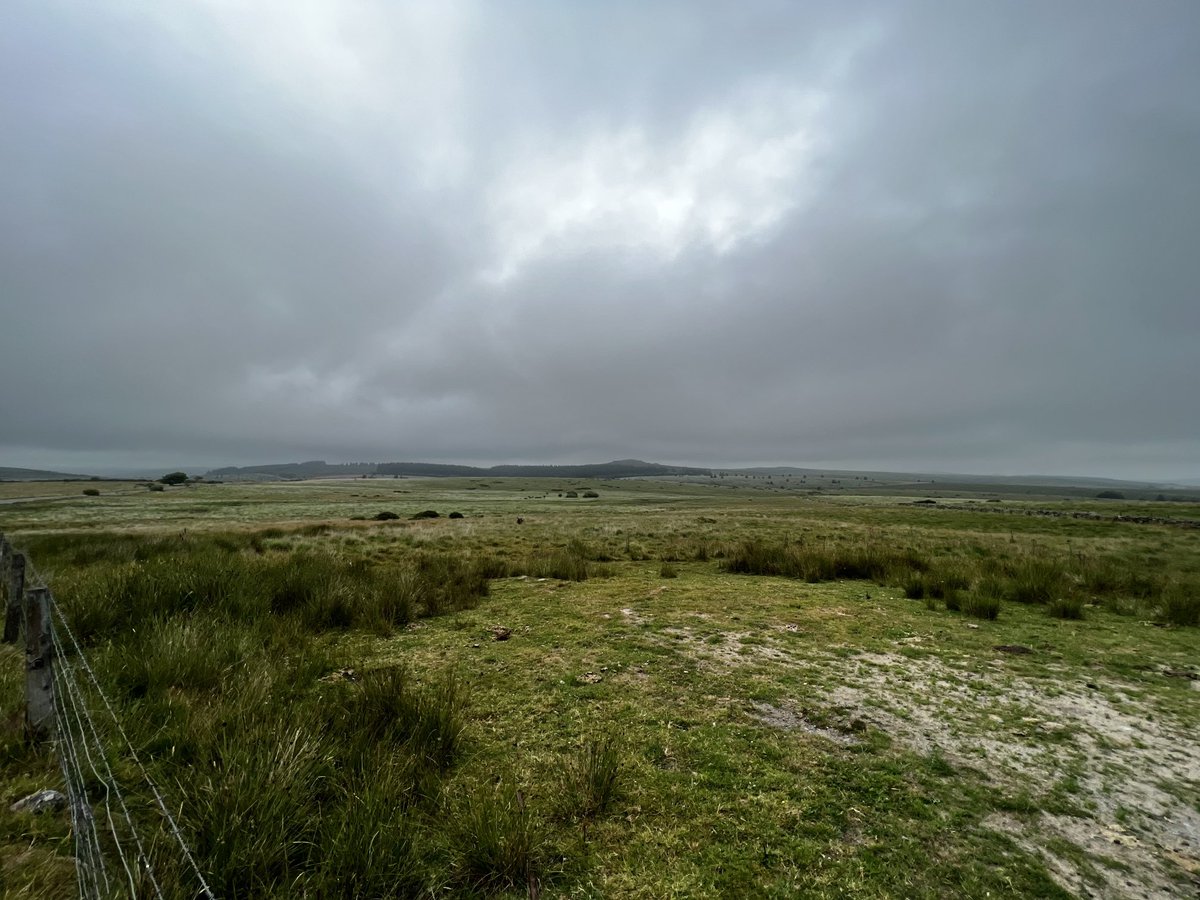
648;611;1200;900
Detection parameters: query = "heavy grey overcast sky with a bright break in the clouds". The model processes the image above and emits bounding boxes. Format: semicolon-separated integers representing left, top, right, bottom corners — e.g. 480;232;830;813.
0;0;1200;479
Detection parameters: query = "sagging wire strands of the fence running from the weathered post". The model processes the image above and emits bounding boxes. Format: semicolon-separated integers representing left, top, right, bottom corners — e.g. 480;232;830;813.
10;558;216;900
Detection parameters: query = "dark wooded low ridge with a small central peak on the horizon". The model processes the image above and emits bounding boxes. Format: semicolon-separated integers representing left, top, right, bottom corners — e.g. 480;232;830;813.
205;460;713;480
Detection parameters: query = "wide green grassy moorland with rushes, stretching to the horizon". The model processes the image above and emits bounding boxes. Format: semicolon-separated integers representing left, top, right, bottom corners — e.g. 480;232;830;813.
0;478;1200;898
